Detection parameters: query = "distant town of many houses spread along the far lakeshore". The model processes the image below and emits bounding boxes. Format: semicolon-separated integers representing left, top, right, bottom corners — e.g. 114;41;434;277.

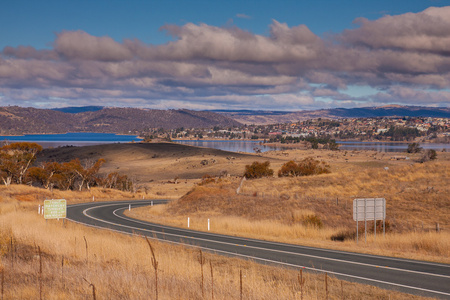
140;117;450;144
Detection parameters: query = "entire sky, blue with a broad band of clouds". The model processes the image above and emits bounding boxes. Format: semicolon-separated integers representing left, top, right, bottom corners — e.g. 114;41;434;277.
0;0;450;111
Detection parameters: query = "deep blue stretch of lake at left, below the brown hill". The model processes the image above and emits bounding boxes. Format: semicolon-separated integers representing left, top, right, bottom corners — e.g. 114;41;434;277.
0;132;141;147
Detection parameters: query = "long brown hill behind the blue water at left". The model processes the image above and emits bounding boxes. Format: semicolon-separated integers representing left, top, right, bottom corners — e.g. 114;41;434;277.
0;106;241;135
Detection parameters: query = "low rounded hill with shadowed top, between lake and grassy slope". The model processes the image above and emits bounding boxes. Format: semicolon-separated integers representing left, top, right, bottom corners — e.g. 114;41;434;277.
35;143;264;184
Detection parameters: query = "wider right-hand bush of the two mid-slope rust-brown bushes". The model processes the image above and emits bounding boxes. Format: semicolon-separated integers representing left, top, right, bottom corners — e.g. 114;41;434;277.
278;157;330;177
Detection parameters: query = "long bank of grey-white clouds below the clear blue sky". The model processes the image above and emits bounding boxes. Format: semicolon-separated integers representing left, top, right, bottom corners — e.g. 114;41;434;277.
0;7;450;109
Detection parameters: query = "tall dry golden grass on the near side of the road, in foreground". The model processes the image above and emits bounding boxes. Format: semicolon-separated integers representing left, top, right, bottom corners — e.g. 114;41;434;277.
0;193;432;299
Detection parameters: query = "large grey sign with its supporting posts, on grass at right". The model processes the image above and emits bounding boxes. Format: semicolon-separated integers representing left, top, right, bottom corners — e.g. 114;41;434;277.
353;198;386;243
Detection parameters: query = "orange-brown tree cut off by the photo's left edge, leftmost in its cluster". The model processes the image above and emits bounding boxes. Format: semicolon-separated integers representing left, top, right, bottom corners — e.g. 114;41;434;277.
0;142;42;185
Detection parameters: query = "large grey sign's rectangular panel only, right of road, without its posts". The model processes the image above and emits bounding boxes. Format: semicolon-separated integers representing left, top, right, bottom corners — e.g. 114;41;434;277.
353;198;386;221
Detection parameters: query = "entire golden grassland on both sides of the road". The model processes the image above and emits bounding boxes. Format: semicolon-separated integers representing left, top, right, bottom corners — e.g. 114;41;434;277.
0;145;450;299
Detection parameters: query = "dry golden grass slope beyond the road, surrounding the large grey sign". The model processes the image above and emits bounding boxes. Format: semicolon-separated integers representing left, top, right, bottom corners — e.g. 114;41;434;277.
129;152;450;263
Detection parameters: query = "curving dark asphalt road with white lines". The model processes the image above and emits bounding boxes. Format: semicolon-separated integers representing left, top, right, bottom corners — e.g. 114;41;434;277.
67;200;450;299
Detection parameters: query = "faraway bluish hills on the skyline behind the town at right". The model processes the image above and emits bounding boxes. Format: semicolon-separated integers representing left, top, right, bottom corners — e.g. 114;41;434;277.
214;105;450;125
